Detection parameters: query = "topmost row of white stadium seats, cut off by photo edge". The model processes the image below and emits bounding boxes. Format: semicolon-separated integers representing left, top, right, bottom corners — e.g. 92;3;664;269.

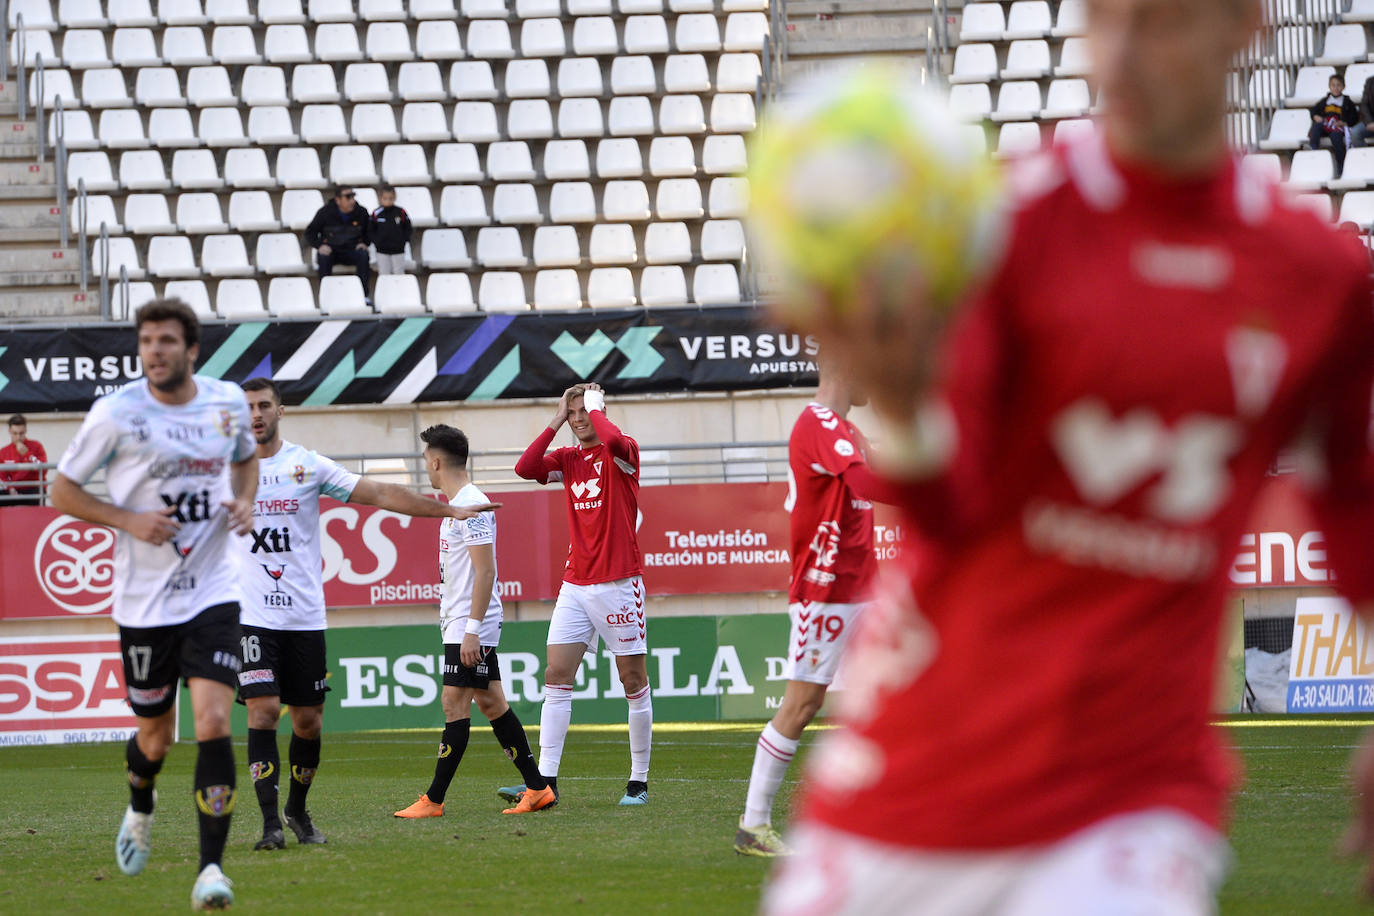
8;0;768;32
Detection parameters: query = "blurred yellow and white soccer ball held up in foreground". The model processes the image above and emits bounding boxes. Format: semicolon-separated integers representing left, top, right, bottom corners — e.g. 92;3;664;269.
749;66;1004;325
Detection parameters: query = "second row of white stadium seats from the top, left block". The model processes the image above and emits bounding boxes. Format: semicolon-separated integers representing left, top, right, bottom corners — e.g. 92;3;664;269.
10;12;768;70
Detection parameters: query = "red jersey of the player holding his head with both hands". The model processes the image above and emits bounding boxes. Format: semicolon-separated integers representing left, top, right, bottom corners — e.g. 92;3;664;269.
515;411;644;585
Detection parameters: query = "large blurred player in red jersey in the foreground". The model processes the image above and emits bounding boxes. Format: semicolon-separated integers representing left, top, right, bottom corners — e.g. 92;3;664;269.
764;0;1374;916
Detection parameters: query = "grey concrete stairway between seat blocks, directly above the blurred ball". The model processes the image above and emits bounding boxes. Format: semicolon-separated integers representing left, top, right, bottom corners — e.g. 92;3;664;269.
782;0;959;82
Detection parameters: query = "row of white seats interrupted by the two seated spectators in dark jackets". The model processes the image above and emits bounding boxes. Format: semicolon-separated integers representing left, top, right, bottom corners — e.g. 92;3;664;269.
91;220;745;277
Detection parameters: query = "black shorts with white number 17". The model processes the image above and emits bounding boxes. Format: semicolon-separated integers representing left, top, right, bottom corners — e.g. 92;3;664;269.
120;602;240;718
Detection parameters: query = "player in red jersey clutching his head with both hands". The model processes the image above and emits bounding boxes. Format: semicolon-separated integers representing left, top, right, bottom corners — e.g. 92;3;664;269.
511;382;654;805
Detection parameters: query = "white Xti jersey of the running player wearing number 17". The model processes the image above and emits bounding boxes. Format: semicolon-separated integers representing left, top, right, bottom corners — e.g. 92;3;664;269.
58;375;254;626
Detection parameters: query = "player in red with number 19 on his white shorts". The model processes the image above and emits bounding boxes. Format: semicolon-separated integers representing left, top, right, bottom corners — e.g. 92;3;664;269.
735;365;878;857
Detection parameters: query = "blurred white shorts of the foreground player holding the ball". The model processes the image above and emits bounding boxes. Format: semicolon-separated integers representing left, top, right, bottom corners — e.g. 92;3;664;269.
761;808;1231;916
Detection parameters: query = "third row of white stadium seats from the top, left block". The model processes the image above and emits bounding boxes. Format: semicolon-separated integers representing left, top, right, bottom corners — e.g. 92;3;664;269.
29;51;763;108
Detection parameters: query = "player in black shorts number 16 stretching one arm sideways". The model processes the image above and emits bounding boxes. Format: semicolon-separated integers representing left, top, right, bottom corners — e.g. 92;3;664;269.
236;378;496;849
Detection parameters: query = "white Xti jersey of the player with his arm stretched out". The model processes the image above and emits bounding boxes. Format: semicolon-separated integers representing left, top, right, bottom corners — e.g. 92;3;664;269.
235;441;359;630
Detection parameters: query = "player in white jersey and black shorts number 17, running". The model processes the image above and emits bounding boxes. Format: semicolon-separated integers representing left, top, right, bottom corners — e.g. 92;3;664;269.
52;299;257;909
